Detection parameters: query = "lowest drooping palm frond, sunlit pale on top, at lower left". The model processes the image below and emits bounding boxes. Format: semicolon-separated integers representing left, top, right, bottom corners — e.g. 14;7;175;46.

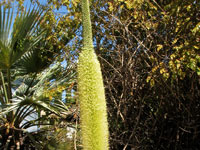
0;96;68;126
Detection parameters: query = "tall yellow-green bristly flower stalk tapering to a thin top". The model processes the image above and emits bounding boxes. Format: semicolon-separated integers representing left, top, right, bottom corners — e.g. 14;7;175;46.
78;0;109;150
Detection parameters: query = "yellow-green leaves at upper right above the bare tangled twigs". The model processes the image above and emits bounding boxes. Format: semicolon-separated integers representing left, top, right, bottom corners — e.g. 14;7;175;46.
108;0;200;83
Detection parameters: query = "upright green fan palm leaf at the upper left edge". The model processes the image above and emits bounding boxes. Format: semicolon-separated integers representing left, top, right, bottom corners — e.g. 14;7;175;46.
0;7;43;69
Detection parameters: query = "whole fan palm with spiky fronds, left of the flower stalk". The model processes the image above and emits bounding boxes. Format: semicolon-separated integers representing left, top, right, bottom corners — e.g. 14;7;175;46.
0;4;75;149
